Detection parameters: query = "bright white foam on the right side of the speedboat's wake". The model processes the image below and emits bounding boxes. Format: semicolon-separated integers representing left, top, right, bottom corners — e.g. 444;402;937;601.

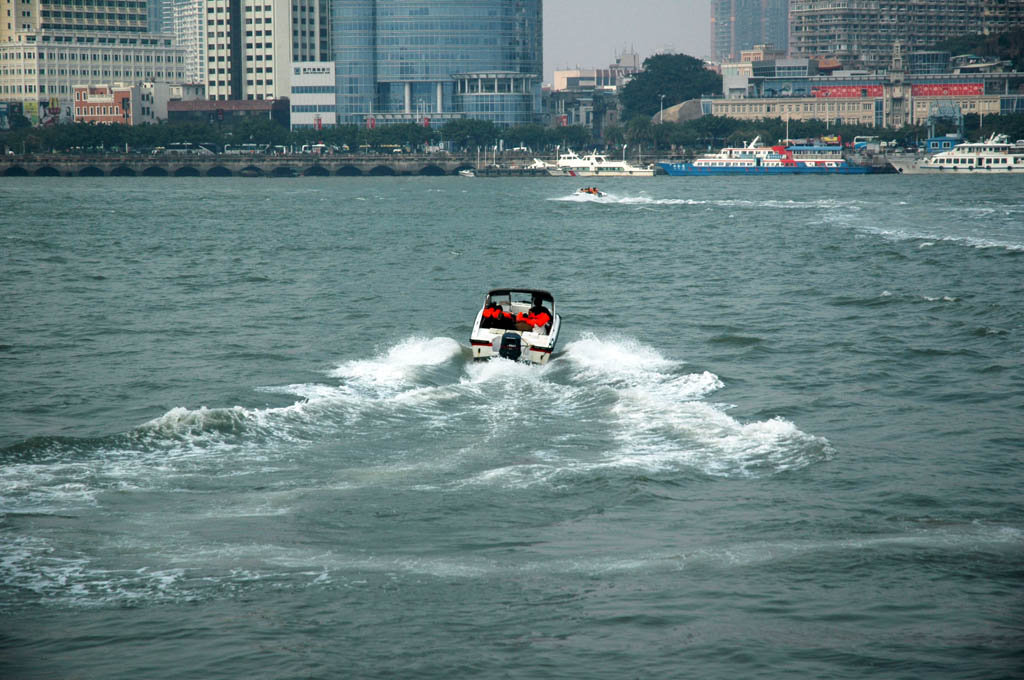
452;334;834;481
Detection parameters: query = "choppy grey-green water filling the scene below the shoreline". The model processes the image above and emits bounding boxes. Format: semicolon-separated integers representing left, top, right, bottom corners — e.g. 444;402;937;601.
0;176;1024;679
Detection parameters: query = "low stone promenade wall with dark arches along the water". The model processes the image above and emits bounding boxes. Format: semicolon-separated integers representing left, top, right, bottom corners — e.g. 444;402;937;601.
0;154;561;177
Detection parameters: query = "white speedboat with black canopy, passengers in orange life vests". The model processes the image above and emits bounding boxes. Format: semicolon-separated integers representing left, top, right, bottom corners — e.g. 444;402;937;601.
469;288;561;365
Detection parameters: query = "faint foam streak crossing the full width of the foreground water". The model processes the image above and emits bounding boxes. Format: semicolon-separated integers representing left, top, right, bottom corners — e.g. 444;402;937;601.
6;522;1024;607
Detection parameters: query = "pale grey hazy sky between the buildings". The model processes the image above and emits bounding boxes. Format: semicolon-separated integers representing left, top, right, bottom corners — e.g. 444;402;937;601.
544;0;711;83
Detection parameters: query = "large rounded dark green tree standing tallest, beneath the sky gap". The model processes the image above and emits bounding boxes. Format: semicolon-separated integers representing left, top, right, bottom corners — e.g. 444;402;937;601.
620;54;722;119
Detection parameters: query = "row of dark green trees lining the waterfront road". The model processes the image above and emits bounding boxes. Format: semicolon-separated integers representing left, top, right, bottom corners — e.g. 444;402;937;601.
8;114;1024;157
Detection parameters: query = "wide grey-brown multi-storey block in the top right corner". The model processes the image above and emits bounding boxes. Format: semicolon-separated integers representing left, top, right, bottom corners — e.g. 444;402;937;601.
790;0;1024;69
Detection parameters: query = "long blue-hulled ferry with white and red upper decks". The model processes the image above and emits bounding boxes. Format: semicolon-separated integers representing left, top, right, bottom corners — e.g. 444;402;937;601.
658;137;878;176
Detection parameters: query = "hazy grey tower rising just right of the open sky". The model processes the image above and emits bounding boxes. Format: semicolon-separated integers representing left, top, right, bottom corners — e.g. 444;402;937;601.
711;0;790;61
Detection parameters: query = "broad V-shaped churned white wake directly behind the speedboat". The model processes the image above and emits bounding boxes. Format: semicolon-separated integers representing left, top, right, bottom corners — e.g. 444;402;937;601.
0;334;833;520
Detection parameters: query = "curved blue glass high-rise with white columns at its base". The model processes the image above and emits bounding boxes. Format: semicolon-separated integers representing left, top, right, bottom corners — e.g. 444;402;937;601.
331;0;543;126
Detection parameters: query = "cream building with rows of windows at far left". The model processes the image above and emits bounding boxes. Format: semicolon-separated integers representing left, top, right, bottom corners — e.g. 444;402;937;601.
0;0;184;123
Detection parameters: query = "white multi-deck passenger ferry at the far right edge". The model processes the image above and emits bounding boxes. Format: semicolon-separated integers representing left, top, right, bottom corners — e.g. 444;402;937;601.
889;134;1024;175
